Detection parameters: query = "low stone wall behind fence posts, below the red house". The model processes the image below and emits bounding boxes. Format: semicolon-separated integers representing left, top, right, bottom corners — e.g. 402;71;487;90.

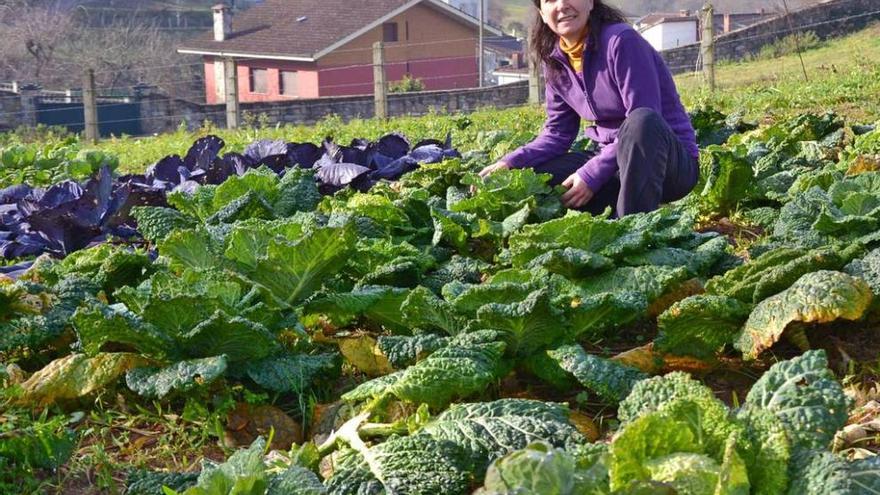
141;81;529;134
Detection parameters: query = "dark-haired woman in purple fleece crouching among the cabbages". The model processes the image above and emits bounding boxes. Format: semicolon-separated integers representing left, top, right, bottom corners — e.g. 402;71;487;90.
480;0;699;217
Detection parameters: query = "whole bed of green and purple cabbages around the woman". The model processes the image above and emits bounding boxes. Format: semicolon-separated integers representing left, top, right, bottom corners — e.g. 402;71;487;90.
0;106;880;494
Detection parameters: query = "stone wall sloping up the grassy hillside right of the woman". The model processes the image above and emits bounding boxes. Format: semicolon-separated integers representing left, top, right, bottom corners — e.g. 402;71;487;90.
661;0;880;74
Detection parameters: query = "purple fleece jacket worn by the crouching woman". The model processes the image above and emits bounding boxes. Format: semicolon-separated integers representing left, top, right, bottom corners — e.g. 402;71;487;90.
503;23;699;193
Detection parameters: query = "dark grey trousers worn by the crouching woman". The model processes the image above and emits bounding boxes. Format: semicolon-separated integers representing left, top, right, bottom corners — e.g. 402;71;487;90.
534;108;700;218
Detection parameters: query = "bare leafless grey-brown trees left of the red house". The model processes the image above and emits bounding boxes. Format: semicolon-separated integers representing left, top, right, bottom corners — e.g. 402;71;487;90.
0;0;204;98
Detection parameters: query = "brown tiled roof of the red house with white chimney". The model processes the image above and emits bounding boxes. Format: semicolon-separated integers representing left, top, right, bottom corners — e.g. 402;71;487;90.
179;0;502;59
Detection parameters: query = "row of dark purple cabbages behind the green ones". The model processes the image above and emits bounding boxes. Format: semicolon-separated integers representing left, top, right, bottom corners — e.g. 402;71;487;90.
0;133;459;258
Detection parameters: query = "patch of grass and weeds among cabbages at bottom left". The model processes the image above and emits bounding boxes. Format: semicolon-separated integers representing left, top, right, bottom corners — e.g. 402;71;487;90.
0;387;272;495
